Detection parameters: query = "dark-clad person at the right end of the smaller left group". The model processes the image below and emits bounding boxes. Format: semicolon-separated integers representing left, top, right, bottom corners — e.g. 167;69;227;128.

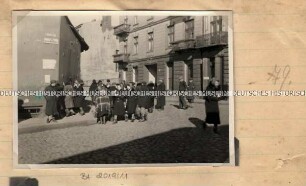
74;80;85;115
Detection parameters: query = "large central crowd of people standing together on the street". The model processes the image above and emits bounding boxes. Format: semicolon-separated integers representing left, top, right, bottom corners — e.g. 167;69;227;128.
89;80;166;124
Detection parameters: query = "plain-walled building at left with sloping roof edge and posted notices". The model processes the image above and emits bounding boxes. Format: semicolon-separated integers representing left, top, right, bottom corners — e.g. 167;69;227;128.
17;16;88;106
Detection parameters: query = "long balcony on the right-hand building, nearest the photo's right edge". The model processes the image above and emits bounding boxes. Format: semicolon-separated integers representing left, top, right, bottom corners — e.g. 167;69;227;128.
196;32;228;48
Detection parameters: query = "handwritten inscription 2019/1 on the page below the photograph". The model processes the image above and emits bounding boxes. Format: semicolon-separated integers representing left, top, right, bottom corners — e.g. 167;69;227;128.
80;172;128;180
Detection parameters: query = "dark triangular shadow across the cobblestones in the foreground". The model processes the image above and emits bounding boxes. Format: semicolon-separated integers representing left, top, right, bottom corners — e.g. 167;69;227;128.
45;123;229;164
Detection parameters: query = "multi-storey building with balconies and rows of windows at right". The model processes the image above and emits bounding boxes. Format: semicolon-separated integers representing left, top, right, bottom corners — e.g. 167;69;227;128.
114;16;229;90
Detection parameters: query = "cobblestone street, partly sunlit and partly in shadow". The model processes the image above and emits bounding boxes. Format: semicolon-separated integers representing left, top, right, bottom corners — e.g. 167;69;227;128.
18;101;229;164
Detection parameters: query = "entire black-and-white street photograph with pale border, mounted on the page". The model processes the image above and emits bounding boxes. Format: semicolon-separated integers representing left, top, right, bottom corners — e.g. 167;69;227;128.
13;11;235;167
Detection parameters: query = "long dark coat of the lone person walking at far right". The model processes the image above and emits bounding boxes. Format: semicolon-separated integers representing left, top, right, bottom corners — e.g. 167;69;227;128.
205;85;220;124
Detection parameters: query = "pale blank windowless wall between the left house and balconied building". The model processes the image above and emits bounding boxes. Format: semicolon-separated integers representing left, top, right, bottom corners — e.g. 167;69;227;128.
76;16;119;84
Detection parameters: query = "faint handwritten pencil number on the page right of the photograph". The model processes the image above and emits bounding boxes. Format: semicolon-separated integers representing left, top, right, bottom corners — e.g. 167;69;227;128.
267;65;291;90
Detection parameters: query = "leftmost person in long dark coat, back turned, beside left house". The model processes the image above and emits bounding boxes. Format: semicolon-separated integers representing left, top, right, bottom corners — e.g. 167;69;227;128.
45;80;58;123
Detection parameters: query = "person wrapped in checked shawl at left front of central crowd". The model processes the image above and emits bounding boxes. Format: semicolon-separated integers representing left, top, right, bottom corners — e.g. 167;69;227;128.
95;86;110;124
